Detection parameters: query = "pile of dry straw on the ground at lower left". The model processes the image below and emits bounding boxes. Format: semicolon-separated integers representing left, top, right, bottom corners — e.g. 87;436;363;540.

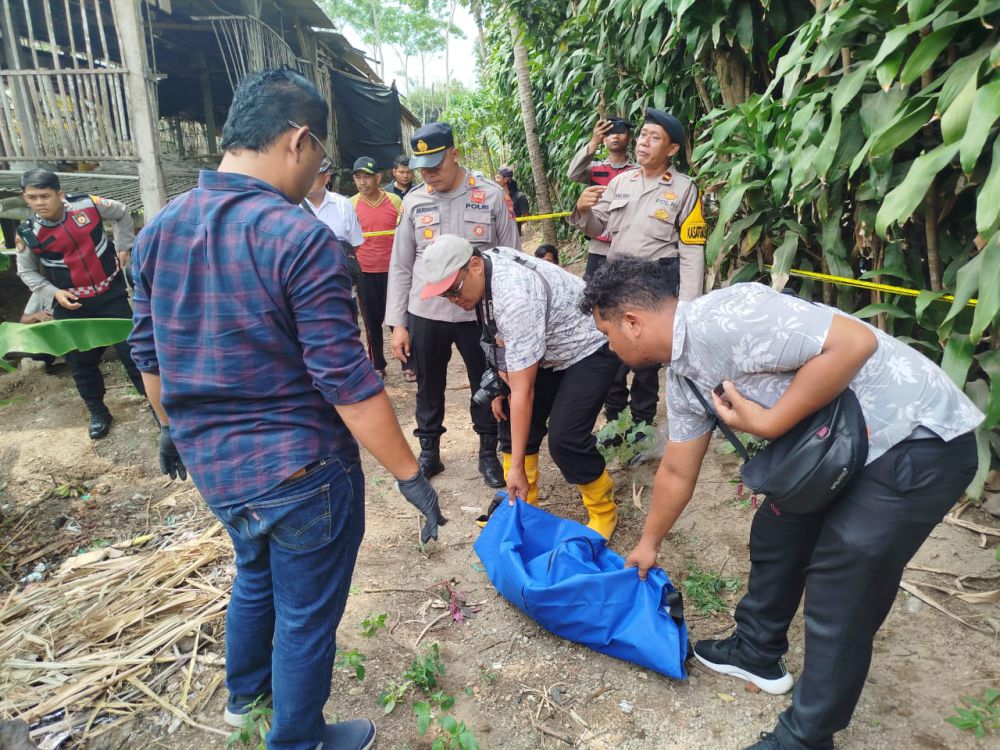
0;523;232;741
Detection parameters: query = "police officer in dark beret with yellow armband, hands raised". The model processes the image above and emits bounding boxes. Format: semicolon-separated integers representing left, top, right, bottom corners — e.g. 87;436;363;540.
569;107;707;434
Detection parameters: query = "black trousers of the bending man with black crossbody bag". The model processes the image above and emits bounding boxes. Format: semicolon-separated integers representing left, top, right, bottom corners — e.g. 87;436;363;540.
736;433;976;750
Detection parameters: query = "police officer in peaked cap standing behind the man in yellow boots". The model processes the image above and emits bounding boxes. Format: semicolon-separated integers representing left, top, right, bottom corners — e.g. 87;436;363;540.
385;122;521;487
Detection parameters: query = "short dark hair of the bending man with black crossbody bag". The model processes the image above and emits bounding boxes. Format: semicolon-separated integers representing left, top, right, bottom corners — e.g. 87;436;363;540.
580;258;676;320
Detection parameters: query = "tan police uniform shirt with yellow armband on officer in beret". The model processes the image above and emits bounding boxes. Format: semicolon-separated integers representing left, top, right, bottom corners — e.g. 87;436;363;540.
569;168;707;300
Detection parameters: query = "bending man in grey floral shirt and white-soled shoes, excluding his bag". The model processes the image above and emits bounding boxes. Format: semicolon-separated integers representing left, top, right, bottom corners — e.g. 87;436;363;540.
582;259;983;750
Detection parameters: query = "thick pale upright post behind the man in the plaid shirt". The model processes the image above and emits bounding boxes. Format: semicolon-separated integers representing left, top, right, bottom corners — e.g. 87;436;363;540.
111;0;167;217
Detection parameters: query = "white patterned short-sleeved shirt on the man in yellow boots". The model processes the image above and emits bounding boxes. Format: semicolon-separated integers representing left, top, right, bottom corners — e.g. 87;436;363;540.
486;247;607;372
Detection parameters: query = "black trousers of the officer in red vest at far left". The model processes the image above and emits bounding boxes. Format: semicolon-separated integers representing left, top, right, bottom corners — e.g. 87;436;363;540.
52;274;146;414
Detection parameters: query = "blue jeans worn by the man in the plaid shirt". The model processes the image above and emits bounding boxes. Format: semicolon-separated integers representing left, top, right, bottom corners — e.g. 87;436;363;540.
212;458;365;750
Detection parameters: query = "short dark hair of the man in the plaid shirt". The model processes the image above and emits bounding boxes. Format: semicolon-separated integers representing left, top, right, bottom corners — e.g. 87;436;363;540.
222;68;327;151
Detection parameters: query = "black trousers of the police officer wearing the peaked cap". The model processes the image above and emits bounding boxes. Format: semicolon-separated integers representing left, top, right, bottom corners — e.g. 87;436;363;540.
410;315;497;438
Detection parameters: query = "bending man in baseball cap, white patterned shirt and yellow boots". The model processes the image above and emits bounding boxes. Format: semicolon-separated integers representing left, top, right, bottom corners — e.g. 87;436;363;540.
420;234;621;539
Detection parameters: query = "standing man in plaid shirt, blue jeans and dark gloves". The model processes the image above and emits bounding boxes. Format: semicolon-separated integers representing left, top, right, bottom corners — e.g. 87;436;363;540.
130;70;444;750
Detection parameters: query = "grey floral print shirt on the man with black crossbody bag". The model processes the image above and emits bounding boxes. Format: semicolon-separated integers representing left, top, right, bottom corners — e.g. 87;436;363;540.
667;283;983;463
